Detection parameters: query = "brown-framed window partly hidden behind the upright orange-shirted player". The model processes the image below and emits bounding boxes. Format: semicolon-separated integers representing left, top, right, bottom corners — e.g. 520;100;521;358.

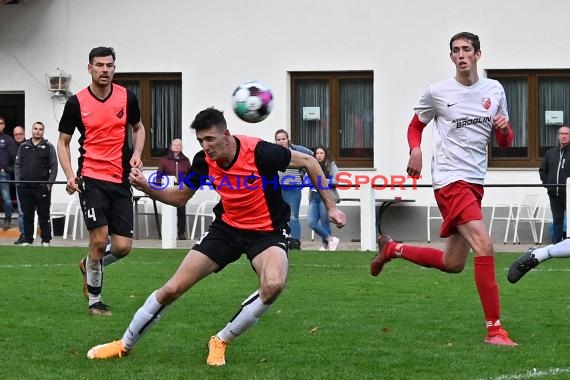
115;73;182;166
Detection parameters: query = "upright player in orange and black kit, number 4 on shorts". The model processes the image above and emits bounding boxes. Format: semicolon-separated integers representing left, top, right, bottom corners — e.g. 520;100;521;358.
57;46;145;316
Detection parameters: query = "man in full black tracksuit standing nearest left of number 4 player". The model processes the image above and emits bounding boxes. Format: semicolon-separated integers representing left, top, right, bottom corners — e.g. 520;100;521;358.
16;121;57;247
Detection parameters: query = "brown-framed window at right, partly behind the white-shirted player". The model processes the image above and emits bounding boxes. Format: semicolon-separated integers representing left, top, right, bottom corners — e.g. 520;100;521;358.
487;70;570;168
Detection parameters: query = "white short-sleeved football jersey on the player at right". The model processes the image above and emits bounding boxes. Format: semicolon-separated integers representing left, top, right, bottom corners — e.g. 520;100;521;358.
414;78;509;189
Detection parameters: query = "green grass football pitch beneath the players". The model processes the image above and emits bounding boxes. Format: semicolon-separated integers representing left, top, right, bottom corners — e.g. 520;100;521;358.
0;246;570;380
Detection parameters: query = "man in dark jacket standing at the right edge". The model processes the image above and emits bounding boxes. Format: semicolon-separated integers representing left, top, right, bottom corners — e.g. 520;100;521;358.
538;125;570;244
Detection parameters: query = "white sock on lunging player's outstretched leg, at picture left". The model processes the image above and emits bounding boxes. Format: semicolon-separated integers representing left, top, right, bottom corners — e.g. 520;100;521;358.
121;290;168;350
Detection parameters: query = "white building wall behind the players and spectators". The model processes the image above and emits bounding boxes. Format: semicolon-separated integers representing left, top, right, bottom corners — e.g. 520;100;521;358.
0;0;570;211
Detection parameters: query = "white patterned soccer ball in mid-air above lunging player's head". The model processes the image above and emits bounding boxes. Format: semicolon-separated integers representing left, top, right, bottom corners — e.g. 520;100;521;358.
232;81;273;123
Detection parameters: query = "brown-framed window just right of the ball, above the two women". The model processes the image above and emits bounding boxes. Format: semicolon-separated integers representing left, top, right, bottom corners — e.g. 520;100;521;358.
290;71;374;168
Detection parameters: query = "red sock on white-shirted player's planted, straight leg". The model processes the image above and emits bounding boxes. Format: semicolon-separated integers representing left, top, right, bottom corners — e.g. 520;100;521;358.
475;256;501;332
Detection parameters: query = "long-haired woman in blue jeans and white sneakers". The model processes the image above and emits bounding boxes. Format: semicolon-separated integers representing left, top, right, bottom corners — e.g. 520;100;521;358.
307;145;340;251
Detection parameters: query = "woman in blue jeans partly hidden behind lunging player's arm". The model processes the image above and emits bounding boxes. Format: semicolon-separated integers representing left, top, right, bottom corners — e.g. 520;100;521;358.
275;129;313;250
